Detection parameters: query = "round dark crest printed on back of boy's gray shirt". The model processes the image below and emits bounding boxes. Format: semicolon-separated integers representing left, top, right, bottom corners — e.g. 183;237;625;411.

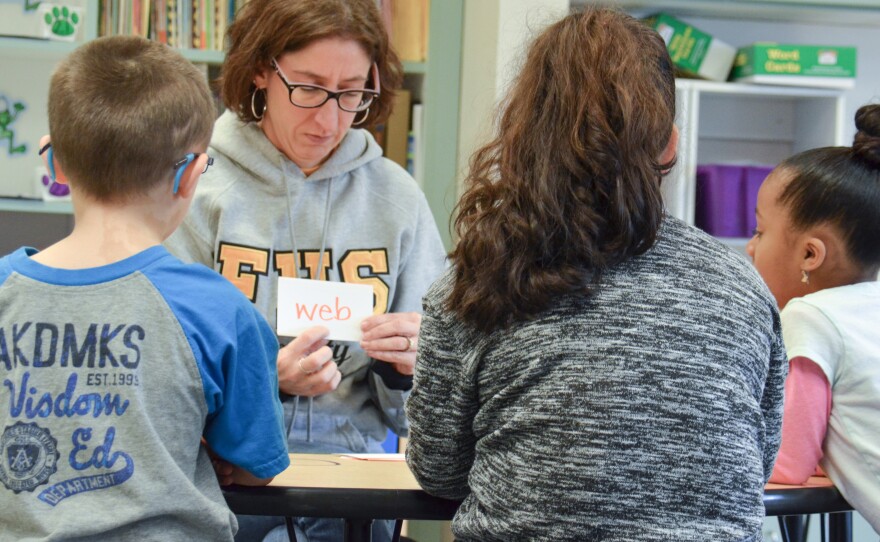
0;422;60;493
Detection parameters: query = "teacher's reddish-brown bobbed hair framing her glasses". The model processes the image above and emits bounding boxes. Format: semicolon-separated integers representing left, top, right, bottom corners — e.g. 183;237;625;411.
220;0;403;128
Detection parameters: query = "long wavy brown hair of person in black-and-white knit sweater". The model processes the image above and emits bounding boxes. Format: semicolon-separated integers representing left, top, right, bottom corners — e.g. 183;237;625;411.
446;8;675;332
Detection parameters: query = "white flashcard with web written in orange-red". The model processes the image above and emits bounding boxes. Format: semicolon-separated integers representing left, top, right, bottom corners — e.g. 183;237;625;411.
277;277;373;341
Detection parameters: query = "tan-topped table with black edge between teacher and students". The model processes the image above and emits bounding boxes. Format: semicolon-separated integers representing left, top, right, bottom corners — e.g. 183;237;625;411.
224;454;852;542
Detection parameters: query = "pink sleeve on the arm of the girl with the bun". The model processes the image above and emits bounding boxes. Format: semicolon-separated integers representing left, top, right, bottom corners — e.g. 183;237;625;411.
770;357;831;485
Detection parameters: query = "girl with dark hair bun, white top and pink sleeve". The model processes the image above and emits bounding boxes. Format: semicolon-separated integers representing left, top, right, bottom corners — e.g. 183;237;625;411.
747;104;880;532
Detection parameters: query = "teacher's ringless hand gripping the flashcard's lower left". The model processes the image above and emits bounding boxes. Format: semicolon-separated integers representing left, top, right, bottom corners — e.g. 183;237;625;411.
278;326;342;397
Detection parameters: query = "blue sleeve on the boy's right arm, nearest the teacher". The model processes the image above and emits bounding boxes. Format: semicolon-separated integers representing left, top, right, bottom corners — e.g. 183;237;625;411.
144;264;290;478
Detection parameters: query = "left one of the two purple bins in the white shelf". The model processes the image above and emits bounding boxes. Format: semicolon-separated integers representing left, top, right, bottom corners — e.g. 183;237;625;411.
694;164;746;237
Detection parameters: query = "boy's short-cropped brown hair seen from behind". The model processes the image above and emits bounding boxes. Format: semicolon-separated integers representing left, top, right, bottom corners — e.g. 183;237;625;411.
49;36;216;201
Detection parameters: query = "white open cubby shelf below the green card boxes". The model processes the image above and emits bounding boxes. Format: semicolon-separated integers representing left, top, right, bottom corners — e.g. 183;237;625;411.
663;79;851;232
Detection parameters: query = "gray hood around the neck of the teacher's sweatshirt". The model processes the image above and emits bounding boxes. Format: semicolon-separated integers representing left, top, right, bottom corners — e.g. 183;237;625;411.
211;110;382;194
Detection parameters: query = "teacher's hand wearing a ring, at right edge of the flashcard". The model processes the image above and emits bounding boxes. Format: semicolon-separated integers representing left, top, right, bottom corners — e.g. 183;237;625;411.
361;312;422;375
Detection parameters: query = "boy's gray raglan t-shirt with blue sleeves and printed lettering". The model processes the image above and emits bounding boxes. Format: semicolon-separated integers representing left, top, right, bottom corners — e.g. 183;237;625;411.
0;246;289;541
